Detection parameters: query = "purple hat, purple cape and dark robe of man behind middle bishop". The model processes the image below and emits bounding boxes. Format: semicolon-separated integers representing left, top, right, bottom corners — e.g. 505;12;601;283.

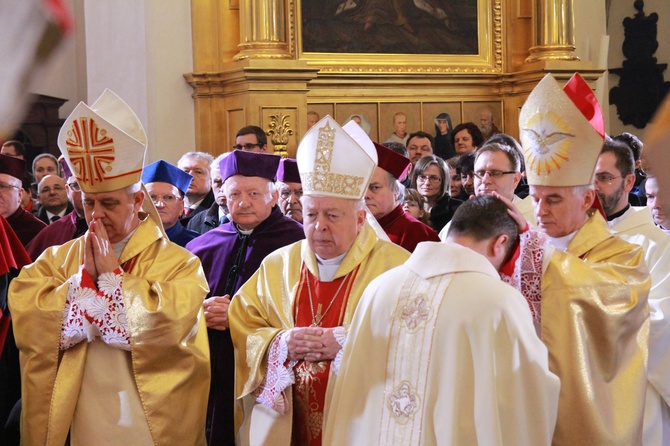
186;150;305;446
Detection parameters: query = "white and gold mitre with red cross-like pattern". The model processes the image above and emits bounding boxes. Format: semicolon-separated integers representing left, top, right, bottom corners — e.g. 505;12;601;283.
58;90;147;192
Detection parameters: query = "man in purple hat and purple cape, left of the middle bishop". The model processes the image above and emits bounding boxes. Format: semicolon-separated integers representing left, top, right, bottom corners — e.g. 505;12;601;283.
186;150;305;446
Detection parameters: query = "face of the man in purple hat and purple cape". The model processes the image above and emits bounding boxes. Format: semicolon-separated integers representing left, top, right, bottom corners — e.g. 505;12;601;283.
223;175;278;230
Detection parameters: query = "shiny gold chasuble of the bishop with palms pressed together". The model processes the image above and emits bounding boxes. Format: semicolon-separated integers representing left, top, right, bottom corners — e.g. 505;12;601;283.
9;213;210;446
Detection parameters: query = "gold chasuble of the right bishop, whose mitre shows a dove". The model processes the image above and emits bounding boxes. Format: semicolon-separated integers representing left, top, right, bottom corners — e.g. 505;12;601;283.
541;212;650;446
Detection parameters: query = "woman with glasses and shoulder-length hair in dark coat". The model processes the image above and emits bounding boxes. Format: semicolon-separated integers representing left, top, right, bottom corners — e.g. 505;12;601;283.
411;155;462;232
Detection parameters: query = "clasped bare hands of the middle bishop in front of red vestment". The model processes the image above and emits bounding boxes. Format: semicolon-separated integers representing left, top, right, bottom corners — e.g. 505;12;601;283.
286;327;342;362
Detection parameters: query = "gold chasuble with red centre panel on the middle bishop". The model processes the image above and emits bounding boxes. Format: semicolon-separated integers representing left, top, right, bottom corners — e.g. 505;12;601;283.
229;223;409;446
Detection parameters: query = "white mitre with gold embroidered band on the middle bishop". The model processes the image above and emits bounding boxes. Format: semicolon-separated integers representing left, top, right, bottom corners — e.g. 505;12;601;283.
296;115;377;199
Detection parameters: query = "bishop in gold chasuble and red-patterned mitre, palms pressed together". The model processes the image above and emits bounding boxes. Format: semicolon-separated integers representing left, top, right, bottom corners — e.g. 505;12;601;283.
9;90;210;446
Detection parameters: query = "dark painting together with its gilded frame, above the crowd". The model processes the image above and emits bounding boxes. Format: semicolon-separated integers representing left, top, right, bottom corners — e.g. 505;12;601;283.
296;0;502;72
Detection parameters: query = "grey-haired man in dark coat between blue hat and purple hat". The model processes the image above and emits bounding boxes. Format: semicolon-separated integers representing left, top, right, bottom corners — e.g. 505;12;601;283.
177;152;214;226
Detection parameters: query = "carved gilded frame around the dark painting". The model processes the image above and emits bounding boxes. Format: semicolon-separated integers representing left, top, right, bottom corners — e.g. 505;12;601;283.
287;0;503;74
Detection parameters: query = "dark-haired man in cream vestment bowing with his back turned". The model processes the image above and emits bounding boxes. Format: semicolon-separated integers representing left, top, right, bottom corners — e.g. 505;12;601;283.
324;195;560;446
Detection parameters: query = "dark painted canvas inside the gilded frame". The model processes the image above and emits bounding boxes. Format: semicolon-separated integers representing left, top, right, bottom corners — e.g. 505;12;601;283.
302;0;478;54
